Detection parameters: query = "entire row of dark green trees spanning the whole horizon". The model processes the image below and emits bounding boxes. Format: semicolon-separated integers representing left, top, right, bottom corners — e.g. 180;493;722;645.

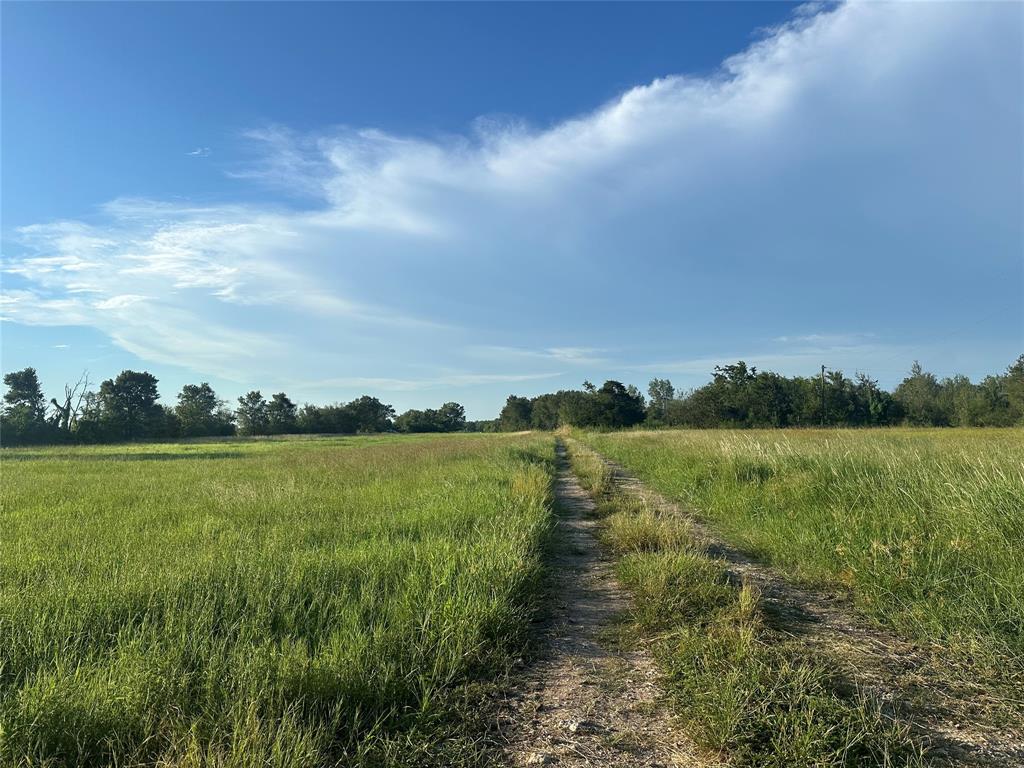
0;355;1024;445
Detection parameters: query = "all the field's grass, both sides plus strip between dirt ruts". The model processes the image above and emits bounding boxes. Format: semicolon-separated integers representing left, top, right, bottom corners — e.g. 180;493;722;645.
6;429;1024;768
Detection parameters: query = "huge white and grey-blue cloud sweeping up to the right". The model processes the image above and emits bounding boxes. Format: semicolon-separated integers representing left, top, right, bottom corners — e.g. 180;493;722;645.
3;3;1024;409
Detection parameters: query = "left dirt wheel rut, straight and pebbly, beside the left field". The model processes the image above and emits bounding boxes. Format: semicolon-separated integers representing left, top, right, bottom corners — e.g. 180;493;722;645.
505;443;698;768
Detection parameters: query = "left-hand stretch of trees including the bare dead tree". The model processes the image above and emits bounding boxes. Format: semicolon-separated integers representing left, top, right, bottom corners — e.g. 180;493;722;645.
0;368;471;445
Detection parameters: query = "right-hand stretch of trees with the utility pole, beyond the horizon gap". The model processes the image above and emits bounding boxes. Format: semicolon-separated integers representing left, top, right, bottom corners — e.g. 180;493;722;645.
497;355;1024;431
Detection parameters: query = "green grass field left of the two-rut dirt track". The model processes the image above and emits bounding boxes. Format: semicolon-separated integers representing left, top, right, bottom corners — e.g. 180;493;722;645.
0;436;553;767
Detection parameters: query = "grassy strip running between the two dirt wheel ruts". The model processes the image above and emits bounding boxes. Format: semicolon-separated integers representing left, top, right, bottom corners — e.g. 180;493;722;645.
570;447;924;768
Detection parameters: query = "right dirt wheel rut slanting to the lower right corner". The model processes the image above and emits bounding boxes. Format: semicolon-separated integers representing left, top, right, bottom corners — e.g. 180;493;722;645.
575;443;1024;767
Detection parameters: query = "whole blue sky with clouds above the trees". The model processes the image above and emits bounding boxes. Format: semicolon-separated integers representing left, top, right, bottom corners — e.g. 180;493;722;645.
0;2;1024;418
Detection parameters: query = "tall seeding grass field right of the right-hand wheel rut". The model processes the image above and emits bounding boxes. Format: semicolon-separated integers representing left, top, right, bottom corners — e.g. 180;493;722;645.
582;429;1024;669
